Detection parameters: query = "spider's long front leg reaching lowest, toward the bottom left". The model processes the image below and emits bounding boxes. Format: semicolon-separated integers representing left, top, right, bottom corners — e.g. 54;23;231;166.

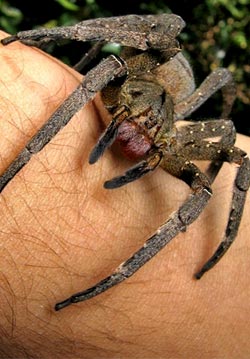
55;156;212;310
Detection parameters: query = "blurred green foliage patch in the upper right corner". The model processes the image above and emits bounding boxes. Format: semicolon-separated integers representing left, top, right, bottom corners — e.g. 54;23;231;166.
184;0;250;134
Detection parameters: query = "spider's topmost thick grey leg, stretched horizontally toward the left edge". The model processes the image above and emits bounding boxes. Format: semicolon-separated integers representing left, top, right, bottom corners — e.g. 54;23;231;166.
2;14;185;50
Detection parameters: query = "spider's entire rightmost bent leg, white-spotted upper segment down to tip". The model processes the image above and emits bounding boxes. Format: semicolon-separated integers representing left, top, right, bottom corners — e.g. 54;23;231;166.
178;120;250;279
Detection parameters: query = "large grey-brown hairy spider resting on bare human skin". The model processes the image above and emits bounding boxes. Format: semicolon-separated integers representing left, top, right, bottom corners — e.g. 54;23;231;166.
0;14;250;310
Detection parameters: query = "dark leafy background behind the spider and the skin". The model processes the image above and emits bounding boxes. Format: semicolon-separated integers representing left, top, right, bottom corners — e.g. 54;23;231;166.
0;0;250;135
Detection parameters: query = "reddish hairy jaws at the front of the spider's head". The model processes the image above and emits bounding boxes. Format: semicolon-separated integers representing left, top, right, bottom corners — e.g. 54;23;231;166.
116;121;152;160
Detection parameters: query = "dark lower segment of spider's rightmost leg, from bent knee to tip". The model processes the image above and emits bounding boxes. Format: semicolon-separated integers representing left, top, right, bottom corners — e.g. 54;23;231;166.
195;156;250;279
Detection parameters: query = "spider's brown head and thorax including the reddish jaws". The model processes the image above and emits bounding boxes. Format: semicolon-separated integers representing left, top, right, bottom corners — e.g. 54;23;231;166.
98;54;174;160
